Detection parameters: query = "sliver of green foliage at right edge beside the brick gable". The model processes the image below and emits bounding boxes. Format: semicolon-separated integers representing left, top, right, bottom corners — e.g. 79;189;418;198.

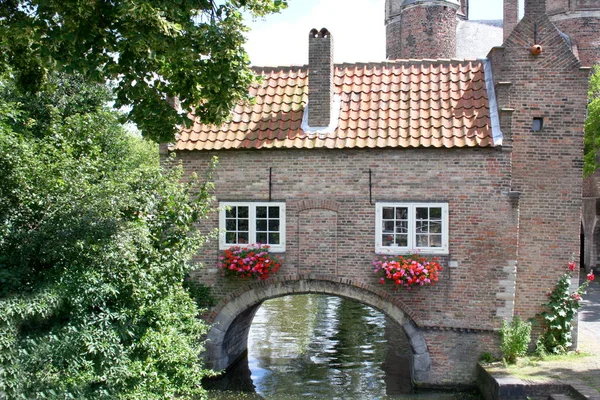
583;66;600;176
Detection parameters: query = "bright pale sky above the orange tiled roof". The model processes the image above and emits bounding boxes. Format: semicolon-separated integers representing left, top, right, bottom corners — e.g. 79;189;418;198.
246;0;502;66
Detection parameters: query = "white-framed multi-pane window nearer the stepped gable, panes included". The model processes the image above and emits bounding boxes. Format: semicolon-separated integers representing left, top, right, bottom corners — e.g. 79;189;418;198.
375;202;448;254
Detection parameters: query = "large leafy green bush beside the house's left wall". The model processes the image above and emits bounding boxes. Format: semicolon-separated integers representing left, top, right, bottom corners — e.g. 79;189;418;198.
0;73;216;400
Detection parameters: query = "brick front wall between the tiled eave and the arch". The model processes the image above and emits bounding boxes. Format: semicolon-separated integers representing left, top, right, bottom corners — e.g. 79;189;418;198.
178;148;517;329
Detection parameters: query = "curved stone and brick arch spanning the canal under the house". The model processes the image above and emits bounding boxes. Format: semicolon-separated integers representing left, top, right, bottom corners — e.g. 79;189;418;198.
205;276;431;383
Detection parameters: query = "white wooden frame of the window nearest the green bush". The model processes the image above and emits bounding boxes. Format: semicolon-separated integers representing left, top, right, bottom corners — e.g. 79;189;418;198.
219;201;286;253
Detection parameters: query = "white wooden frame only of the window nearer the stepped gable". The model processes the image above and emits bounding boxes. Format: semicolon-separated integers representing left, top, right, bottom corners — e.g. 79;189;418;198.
375;202;448;254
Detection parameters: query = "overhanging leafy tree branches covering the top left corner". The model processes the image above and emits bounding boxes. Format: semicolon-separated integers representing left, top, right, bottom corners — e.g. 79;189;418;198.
0;0;286;141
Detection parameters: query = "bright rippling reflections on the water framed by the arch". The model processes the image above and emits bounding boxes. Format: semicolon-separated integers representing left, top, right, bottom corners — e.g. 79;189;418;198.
248;295;398;398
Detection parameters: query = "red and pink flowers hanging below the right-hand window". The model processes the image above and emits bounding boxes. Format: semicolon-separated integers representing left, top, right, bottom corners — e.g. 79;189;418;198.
373;254;443;289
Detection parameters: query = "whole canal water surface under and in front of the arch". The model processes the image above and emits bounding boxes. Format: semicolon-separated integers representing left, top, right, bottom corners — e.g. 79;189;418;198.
206;294;481;400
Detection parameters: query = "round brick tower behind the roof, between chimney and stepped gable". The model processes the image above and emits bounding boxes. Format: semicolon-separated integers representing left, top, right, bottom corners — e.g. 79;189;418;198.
385;0;468;59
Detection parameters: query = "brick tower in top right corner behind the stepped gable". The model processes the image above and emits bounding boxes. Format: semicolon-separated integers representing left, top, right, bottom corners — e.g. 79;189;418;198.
547;0;600;66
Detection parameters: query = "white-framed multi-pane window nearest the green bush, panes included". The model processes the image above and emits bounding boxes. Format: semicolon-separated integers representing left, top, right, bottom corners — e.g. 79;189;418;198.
219;201;285;252
